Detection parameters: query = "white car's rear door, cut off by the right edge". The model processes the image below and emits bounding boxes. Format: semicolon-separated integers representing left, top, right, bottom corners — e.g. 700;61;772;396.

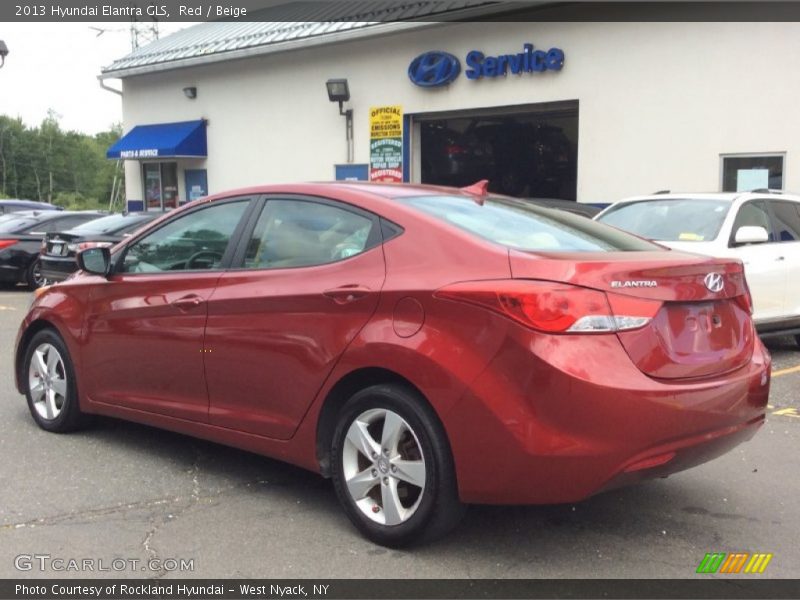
769;200;800;326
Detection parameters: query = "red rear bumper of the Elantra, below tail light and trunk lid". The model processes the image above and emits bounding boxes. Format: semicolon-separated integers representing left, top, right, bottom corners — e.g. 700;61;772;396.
443;333;770;504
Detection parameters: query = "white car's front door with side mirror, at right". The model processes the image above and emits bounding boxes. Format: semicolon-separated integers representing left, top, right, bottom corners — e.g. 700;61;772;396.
728;200;786;323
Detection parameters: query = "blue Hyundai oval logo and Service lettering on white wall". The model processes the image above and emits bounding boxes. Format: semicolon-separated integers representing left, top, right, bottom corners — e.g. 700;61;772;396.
408;44;564;87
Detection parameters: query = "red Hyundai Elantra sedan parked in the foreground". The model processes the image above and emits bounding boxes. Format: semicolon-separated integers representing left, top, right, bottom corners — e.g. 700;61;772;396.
16;183;770;546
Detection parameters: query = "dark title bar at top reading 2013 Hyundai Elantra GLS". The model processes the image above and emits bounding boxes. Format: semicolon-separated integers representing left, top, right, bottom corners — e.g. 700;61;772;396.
0;0;800;23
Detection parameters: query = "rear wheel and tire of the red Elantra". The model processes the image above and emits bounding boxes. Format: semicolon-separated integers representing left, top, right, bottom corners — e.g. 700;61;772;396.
331;385;466;548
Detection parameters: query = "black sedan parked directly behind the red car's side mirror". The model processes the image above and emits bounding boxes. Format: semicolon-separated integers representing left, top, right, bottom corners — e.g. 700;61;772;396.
40;212;164;283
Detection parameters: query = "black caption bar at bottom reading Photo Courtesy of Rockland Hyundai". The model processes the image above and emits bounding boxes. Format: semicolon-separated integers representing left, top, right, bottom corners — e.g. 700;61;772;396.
0;576;800;600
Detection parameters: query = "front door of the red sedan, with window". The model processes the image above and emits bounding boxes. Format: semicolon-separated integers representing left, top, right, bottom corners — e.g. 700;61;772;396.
83;198;251;422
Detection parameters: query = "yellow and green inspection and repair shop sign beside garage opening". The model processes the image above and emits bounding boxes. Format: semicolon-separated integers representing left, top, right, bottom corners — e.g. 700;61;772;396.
369;105;403;183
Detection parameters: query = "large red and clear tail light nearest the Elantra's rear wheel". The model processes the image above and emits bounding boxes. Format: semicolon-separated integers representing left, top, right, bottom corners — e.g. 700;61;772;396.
434;280;661;333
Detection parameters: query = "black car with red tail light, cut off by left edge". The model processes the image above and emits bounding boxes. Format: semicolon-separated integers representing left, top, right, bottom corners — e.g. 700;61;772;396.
0;210;105;288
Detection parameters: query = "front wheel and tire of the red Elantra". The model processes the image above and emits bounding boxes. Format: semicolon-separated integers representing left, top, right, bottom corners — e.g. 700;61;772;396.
21;329;89;433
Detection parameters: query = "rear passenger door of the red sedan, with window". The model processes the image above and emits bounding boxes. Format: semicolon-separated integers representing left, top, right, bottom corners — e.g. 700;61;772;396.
203;197;386;439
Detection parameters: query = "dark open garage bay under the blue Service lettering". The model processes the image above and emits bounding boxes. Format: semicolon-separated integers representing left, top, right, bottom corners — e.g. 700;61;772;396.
415;102;578;200
